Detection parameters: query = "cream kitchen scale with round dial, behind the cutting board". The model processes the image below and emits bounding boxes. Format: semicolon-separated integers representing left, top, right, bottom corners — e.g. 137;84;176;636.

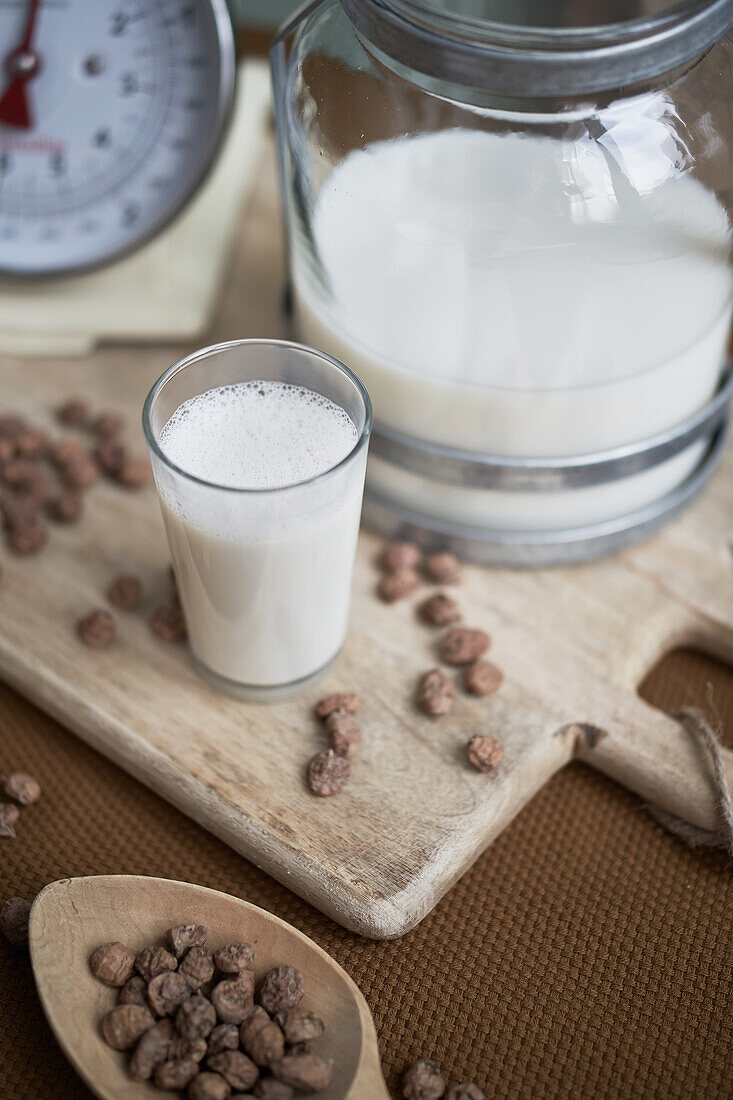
0;0;270;354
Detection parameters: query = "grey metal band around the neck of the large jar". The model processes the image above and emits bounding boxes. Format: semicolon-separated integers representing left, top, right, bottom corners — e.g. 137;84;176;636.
340;0;733;99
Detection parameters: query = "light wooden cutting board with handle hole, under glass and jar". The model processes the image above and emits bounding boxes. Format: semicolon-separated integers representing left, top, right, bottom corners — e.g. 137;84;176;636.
0;151;733;938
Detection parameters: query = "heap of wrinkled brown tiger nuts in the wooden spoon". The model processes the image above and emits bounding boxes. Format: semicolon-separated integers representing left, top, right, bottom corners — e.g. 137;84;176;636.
89;924;332;1100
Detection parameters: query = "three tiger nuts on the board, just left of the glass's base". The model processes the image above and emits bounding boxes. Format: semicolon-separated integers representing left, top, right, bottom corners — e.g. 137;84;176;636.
76;569;187;649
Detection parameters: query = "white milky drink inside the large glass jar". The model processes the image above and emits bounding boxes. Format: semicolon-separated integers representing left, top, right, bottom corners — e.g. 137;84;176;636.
294;128;733;530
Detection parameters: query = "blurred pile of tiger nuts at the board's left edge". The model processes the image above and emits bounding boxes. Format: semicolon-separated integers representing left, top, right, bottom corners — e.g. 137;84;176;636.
0;400;150;556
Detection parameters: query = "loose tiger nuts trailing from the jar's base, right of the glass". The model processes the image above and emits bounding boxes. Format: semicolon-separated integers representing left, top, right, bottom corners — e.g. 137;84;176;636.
378;542;504;772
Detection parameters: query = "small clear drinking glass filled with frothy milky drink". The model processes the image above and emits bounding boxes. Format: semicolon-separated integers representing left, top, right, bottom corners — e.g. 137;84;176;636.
143;340;372;702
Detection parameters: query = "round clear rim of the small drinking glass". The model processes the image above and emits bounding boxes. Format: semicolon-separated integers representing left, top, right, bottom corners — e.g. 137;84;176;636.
142;337;374;496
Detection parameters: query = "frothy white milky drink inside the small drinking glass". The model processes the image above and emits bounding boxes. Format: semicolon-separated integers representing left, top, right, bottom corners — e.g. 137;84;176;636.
145;356;367;690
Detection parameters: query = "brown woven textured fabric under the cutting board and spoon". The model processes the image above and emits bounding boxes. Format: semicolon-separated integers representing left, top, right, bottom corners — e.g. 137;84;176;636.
0;653;733;1100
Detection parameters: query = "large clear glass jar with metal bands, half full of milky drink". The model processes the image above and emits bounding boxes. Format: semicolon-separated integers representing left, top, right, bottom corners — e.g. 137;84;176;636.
272;0;733;563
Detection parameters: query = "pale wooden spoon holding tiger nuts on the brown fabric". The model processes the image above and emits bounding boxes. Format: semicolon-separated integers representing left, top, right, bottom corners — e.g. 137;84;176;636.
29;875;389;1100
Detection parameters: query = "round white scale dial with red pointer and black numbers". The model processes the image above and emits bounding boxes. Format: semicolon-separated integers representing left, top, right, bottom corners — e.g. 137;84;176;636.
0;0;234;276
